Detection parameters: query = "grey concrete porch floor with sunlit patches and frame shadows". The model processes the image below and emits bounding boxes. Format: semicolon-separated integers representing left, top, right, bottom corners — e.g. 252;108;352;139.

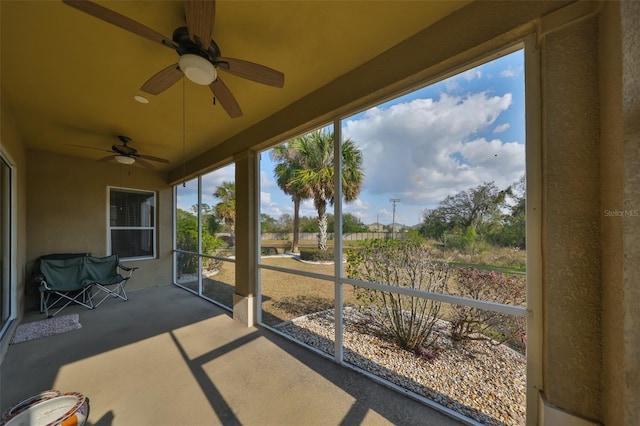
0;286;460;426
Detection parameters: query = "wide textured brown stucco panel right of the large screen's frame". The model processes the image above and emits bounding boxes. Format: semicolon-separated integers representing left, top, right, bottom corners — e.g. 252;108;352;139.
542;10;602;419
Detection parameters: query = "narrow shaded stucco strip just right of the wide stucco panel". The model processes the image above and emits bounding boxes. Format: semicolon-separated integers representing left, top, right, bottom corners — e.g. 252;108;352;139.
599;2;624;425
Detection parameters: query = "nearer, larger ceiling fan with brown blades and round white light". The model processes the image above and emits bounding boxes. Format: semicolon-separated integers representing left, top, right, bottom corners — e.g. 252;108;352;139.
62;0;284;118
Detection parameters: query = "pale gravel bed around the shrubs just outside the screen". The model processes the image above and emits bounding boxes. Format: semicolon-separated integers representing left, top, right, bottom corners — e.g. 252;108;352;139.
275;308;526;425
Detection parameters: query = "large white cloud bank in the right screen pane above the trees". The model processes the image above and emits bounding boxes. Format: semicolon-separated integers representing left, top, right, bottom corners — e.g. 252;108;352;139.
344;92;524;212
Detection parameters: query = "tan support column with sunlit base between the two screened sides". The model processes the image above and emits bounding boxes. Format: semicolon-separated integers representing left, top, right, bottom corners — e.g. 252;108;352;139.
233;151;259;327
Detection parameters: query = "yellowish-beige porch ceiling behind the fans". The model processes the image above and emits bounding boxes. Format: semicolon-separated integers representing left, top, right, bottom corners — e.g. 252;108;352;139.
0;0;468;171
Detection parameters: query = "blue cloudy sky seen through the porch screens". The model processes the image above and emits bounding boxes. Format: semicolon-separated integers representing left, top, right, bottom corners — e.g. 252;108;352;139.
178;51;525;230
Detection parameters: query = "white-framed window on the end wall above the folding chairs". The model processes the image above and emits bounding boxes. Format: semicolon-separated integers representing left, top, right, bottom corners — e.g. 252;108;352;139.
108;188;156;259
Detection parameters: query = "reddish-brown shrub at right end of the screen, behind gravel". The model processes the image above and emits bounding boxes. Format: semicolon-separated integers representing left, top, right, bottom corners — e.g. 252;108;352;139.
451;268;526;343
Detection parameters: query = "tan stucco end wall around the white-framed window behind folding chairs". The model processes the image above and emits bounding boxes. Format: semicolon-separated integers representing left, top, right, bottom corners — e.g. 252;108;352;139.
27;150;173;300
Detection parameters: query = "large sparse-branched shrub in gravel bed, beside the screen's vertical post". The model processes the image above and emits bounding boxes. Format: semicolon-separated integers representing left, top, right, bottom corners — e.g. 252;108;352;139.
347;239;449;350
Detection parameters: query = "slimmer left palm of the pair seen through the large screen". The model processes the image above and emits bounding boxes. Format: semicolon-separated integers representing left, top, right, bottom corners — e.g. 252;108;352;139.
270;143;306;253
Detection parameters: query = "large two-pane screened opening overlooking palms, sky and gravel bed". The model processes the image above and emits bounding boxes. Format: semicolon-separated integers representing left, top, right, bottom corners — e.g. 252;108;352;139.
258;45;535;424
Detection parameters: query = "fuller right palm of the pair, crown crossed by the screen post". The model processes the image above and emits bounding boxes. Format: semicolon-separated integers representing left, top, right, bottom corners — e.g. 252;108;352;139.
291;130;364;250
